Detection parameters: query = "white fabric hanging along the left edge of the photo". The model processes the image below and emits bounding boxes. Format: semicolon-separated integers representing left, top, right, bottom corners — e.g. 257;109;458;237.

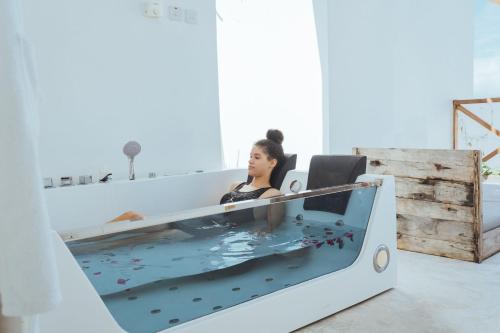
0;0;60;317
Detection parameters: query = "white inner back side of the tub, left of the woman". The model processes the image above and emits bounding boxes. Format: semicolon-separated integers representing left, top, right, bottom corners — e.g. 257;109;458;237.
45;169;247;231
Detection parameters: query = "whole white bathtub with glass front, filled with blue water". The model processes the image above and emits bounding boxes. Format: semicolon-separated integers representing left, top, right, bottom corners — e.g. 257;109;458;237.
40;170;397;333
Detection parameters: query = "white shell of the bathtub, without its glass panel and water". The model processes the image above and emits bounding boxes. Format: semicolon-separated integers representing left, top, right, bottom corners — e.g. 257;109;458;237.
40;170;397;333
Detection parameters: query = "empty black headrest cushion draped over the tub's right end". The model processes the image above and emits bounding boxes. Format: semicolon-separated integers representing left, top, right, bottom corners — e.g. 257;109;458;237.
304;155;366;214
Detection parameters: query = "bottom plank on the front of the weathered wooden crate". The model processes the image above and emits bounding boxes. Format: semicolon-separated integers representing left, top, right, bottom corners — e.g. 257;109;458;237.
398;233;475;261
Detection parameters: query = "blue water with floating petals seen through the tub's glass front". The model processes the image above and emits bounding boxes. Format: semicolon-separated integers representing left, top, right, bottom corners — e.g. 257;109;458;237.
68;188;376;333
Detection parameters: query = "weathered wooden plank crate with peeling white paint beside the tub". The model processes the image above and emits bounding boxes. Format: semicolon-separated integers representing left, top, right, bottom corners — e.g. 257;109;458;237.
353;148;500;262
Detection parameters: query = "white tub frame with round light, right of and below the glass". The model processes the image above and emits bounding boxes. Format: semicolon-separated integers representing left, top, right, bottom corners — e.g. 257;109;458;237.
163;175;397;333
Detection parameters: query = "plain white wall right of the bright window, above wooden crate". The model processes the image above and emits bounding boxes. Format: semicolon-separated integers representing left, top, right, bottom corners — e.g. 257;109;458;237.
328;0;473;153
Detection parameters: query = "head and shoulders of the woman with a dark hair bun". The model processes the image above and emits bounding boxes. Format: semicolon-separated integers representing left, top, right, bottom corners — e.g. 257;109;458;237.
220;129;285;204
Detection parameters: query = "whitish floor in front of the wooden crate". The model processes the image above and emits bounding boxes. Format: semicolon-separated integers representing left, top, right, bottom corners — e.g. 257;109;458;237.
296;251;500;333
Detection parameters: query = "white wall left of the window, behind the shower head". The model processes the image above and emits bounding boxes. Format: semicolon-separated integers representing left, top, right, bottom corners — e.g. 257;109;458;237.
23;0;222;179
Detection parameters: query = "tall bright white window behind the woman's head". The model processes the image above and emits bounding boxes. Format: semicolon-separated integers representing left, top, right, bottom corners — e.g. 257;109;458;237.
217;0;323;169
